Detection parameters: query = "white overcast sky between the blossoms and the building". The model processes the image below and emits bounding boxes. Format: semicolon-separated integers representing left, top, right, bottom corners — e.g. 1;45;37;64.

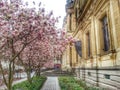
23;0;66;28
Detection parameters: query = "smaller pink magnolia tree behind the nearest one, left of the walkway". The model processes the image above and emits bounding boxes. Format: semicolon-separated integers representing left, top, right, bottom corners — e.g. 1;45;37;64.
19;40;53;83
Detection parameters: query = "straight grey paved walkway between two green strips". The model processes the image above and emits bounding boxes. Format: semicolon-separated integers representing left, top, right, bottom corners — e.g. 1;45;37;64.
41;77;60;90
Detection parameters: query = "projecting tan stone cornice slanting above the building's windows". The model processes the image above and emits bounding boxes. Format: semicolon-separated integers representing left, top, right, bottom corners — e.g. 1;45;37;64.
73;0;109;37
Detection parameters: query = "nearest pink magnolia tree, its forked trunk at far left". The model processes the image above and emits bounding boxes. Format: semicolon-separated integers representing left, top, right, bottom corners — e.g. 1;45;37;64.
0;0;54;90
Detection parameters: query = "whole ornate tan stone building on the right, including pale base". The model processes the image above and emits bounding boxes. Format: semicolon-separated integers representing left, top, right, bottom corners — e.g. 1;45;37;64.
62;0;120;90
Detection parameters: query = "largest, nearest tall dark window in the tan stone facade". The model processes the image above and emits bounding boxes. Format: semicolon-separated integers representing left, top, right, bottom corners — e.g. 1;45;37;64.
101;16;110;51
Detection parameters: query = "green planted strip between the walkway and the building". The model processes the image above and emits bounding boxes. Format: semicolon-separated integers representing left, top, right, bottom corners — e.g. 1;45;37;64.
58;76;104;90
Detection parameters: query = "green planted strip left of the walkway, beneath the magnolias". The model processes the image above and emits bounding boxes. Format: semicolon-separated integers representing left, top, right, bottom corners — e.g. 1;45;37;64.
12;76;46;90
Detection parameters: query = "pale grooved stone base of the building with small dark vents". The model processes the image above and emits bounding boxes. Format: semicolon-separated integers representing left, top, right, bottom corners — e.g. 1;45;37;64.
76;67;120;90
